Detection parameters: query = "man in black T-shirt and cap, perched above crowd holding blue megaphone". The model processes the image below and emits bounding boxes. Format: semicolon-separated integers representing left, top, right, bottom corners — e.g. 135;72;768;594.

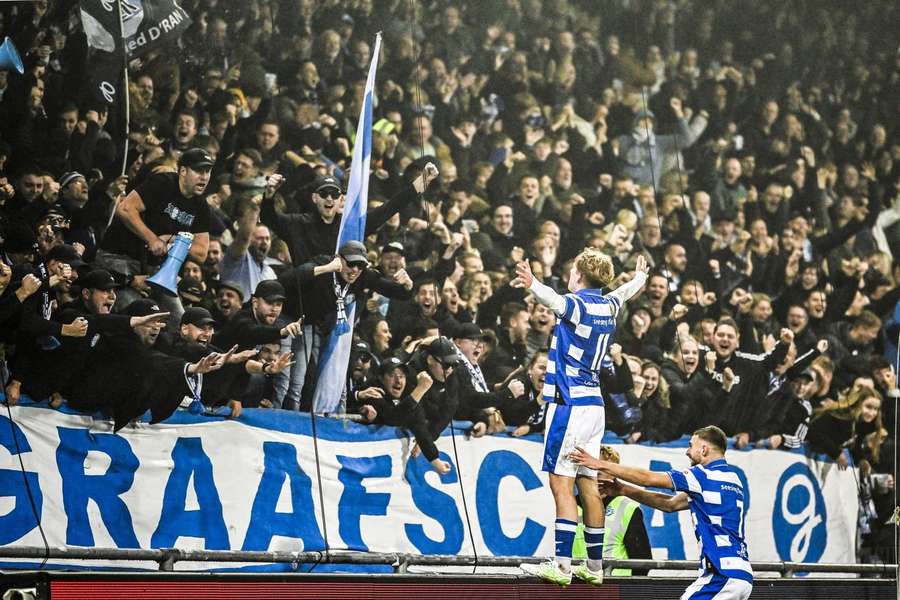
96;148;215;331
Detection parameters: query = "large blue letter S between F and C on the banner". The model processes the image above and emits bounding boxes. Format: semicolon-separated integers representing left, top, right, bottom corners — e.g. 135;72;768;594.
403;452;465;554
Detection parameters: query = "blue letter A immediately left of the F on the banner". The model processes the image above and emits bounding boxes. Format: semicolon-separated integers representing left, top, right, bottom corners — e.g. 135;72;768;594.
241;442;325;551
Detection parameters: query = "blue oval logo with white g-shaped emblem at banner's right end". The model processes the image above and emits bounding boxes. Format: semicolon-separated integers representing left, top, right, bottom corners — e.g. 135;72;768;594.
772;463;828;562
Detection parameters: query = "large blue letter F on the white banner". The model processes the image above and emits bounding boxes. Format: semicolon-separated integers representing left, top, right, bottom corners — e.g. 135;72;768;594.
337;455;391;552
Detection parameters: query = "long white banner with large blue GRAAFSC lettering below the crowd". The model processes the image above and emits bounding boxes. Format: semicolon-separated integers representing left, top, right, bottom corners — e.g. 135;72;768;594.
0;405;857;569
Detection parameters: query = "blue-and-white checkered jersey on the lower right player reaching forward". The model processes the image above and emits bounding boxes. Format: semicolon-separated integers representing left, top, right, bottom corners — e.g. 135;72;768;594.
669;458;753;582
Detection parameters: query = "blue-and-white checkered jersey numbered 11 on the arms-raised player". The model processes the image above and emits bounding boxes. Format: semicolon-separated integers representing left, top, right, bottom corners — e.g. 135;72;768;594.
543;289;622;406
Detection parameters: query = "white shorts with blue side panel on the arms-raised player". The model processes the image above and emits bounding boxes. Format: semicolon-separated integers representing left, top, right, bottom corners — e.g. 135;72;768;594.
541;404;606;477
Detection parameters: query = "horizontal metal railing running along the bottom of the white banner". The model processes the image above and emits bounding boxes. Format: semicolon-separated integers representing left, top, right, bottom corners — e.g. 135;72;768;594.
0;546;897;579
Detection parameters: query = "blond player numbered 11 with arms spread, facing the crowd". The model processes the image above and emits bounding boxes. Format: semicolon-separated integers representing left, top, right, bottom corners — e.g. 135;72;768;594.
511;248;649;585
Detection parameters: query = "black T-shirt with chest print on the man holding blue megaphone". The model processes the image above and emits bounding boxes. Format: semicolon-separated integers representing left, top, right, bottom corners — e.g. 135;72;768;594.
101;173;210;260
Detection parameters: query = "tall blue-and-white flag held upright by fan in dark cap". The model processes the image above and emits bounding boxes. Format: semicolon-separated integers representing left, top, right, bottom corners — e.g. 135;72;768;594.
313;33;381;413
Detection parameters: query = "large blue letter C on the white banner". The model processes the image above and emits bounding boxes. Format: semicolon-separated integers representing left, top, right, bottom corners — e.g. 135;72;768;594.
475;450;547;556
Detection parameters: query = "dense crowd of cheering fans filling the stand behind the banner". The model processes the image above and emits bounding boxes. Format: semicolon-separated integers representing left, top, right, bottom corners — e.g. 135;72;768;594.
0;0;900;555
